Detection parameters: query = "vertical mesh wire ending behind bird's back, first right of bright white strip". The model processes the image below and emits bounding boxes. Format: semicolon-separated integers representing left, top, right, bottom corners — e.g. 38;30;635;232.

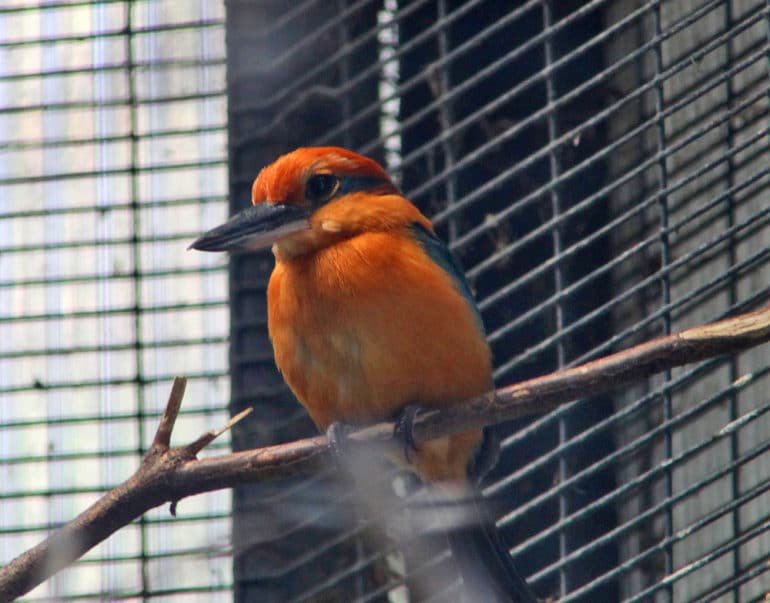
433;0;459;243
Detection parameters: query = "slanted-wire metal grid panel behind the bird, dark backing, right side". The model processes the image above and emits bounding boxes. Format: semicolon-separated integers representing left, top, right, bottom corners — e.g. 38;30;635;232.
228;0;770;601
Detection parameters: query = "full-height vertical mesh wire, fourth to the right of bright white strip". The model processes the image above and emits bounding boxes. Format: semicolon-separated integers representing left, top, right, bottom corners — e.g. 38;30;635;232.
724;0;741;603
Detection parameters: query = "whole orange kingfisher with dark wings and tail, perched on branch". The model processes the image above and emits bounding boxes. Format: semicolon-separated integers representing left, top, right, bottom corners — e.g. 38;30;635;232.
191;147;536;601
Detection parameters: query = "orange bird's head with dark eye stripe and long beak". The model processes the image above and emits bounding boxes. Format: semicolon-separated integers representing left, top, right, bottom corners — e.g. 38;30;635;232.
190;147;430;260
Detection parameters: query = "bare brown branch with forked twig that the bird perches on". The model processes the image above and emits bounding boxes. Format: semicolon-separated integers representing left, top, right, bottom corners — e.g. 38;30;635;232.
0;306;770;601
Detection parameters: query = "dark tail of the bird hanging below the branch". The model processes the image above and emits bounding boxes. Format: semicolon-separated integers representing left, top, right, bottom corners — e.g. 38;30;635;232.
447;497;537;603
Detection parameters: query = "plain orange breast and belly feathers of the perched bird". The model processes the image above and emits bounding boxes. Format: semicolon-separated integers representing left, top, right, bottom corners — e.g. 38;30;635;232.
268;218;492;480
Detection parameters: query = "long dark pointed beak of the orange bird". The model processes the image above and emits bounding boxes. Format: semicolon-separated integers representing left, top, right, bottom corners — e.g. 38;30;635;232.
188;202;310;251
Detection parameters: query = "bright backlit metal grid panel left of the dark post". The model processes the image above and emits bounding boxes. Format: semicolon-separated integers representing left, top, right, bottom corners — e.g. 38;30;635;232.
0;0;232;601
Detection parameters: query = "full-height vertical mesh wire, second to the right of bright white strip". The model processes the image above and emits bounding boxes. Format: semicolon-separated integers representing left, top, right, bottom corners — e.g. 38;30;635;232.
542;0;570;597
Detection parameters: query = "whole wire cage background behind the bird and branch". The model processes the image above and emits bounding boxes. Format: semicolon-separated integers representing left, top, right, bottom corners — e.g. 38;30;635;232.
0;0;770;602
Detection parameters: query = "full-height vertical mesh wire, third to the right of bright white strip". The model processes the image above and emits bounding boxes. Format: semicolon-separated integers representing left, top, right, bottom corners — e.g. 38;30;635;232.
652;3;674;600
